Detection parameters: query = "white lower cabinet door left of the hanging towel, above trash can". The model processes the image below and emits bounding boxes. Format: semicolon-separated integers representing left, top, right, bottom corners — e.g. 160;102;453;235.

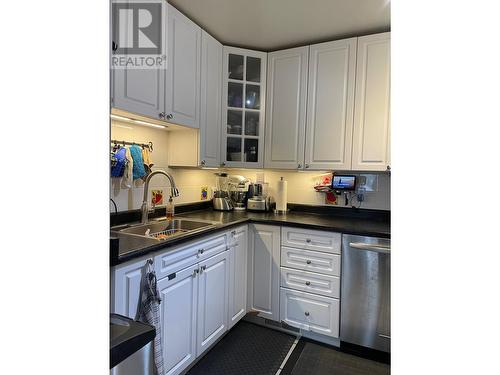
111;259;146;319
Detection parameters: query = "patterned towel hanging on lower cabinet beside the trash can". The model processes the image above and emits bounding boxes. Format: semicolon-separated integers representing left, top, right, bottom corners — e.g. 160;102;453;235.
138;261;164;375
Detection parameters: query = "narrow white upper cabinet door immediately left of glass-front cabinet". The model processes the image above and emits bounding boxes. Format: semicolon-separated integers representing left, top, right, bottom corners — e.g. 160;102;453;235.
200;31;222;167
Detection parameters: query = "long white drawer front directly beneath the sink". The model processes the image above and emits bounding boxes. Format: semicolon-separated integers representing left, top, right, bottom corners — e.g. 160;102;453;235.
155;235;226;280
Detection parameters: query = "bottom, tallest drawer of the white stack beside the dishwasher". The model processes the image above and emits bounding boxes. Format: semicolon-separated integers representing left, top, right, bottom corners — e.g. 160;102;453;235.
280;288;339;337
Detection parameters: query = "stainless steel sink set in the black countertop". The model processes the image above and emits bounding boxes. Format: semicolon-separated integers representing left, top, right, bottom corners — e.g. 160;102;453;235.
112;219;215;240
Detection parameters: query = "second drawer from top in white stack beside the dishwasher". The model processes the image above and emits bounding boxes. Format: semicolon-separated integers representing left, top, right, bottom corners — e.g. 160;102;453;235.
281;246;340;276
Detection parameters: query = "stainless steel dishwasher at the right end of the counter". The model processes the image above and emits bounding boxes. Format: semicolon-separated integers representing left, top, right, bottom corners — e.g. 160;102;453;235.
340;235;391;353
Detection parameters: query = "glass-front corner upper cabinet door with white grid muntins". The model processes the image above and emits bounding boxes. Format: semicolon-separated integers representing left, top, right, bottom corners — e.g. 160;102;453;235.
221;47;267;168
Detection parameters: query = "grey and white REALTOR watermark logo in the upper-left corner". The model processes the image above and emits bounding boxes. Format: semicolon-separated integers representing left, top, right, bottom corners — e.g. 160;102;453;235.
111;0;167;69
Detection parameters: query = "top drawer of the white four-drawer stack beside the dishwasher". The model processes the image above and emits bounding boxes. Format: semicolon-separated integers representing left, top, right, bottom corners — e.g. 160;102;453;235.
281;227;342;254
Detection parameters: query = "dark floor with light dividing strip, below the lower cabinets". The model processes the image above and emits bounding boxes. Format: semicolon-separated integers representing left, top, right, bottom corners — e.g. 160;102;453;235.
187;321;390;375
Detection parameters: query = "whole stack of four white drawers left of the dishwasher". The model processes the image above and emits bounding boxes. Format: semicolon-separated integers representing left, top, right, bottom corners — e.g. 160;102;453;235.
280;227;342;337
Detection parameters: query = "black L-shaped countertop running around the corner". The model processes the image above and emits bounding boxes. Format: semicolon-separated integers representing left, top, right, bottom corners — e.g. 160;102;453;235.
111;207;390;266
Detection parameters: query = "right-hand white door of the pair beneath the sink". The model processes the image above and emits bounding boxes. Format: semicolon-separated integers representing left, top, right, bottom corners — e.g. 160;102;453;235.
197;251;229;356
